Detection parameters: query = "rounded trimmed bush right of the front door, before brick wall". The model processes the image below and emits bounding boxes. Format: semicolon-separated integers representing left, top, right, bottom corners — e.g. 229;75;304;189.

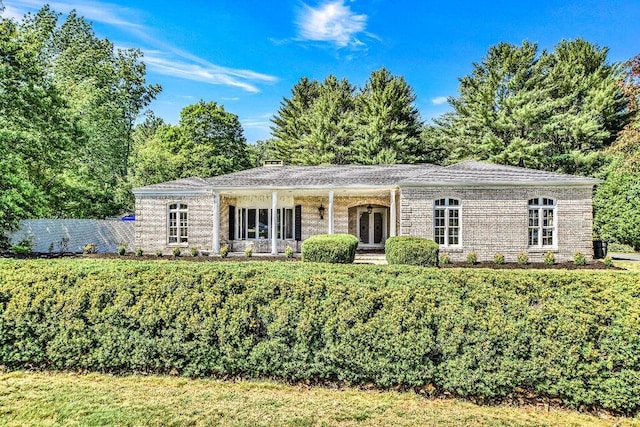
384;236;440;267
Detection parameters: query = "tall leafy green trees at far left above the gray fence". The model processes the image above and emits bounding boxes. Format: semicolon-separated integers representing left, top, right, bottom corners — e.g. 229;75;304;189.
0;6;160;241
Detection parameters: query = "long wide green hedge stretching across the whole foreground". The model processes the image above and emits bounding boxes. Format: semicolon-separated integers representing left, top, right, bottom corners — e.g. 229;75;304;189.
0;260;640;415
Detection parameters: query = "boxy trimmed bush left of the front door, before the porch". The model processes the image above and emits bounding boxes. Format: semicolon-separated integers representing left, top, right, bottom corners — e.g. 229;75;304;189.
302;234;358;264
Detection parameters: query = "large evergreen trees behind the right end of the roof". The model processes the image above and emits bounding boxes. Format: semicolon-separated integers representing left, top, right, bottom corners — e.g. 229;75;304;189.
440;39;627;174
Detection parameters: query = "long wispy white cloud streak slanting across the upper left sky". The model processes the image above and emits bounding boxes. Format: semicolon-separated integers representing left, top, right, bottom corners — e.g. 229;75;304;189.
5;0;278;93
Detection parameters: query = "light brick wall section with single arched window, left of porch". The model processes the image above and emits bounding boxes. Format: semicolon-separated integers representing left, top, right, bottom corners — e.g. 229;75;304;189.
135;195;215;254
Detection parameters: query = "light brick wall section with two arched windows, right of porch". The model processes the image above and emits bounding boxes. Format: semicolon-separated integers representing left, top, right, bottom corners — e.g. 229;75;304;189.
400;187;593;262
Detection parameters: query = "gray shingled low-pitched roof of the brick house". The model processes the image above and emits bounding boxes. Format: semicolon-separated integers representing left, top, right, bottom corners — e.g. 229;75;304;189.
134;161;600;193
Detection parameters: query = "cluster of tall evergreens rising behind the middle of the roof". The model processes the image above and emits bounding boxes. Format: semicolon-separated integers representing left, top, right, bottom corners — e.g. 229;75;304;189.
270;68;425;165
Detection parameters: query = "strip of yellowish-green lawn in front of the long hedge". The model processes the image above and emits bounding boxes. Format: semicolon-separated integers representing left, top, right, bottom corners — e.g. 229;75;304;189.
0;372;640;426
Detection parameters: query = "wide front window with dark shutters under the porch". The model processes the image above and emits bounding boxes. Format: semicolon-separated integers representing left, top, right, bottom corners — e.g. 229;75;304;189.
236;208;295;240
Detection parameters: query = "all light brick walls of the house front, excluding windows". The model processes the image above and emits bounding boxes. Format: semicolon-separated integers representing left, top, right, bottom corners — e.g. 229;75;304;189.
135;187;593;262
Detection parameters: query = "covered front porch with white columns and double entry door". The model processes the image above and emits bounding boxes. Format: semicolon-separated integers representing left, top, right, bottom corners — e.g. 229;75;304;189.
213;188;399;255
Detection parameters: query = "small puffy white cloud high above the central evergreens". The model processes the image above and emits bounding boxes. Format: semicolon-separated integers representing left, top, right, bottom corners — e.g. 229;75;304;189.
296;0;367;47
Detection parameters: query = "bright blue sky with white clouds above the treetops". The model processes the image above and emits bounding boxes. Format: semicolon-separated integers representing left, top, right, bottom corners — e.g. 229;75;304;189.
3;0;640;142
